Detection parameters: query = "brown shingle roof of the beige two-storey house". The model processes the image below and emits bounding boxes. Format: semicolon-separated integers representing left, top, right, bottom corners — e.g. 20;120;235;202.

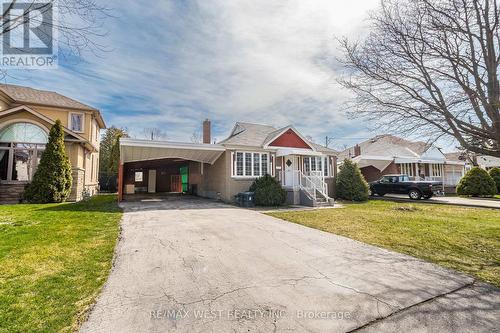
0;84;105;128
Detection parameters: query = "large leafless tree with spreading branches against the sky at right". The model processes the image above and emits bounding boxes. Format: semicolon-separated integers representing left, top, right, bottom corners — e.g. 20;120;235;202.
340;0;500;157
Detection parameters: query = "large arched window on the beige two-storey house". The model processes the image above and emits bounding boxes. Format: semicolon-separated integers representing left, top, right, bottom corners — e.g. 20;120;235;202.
0;122;48;182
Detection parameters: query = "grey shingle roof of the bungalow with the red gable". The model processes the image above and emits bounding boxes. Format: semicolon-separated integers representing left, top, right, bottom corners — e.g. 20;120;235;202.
219;122;338;155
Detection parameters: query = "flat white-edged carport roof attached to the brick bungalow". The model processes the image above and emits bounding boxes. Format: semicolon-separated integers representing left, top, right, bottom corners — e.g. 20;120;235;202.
120;138;226;164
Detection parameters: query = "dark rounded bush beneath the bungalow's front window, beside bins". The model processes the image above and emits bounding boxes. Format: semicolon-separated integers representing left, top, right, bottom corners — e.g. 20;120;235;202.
249;175;286;206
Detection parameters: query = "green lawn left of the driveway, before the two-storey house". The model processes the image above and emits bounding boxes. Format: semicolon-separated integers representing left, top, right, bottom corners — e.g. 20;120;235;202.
0;195;122;332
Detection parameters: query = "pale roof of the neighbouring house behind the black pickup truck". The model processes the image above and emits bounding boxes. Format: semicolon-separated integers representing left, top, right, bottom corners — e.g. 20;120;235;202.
340;134;431;159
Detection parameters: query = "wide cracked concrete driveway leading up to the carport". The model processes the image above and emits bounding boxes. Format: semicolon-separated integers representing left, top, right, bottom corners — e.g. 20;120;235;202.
81;199;500;333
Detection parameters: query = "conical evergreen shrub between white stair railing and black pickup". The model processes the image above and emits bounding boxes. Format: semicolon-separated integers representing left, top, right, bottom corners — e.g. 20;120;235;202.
336;159;370;201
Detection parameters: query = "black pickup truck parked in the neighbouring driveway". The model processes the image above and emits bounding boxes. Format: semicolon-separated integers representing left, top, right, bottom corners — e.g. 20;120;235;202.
370;175;442;200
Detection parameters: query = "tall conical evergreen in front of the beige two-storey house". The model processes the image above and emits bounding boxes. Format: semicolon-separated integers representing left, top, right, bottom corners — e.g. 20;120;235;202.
23;119;73;203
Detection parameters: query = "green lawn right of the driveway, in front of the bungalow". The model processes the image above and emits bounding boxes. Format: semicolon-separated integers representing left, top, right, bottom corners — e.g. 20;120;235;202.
269;200;500;287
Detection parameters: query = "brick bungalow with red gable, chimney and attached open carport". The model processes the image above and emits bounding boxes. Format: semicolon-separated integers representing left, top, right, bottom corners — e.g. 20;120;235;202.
118;120;337;206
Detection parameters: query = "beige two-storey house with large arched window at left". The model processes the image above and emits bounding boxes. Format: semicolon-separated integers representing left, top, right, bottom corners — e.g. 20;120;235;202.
0;84;105;202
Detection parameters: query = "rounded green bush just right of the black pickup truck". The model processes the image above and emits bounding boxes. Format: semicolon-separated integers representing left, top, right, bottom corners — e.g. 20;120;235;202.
457;167;496;197
